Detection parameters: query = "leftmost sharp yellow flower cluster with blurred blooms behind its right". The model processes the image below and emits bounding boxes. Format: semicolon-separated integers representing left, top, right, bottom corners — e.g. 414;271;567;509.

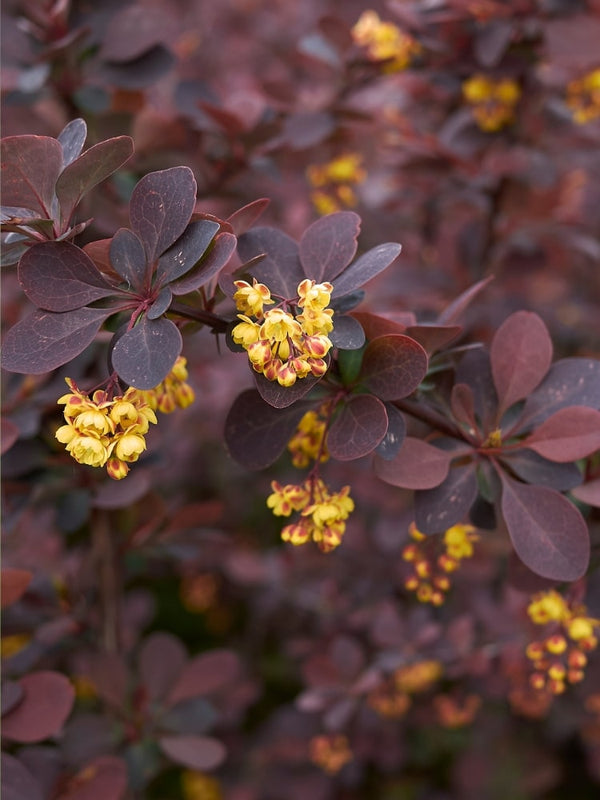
55;357;194;480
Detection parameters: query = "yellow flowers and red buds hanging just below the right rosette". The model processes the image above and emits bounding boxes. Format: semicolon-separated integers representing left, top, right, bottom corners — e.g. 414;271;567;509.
402;522;479;606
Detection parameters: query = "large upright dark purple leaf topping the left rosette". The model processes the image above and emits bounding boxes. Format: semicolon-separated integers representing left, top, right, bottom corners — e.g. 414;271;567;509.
129;167;196;263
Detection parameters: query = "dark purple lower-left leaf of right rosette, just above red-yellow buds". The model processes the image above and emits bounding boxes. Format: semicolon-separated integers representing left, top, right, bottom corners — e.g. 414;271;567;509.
415;463;477;534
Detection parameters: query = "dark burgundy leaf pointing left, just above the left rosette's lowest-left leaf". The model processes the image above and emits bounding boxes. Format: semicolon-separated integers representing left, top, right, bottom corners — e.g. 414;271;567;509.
18;242;115;311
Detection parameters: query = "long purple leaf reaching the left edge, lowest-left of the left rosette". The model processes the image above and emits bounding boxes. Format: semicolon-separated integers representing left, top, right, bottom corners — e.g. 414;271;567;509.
2;308;114;375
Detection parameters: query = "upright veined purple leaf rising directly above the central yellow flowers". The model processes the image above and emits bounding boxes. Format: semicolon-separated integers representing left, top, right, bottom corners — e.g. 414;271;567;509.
298;211;360;283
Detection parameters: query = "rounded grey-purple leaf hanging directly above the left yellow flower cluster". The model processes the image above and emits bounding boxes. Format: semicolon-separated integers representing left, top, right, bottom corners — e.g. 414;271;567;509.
112;316;183;389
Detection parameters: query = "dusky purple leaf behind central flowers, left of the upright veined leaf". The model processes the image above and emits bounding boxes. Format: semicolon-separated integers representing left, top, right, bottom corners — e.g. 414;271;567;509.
238;228;306;300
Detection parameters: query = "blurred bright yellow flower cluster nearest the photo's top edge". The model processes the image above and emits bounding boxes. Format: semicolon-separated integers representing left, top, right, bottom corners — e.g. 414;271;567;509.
352;9;421;72
